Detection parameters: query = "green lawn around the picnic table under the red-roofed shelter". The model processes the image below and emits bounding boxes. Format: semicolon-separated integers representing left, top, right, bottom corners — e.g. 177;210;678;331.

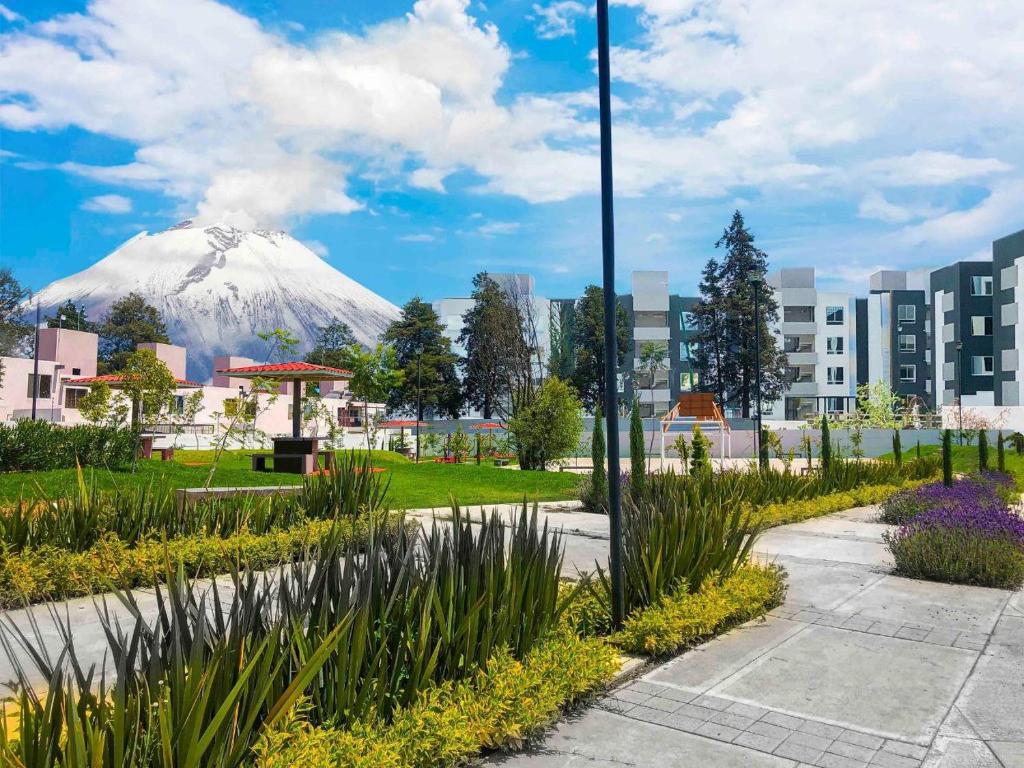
0;451;578;509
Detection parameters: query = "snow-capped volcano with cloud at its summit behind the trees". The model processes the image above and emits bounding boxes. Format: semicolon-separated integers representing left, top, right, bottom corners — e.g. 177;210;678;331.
37;221;398;381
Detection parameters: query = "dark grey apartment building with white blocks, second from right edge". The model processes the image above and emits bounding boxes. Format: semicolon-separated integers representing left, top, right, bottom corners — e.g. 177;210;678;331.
930;261;995;408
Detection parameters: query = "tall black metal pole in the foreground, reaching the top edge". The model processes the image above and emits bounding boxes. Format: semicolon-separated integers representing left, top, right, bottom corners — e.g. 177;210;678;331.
597;0;626;629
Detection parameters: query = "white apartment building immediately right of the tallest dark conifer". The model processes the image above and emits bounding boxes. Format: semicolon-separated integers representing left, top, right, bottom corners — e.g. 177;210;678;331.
764;267;856;421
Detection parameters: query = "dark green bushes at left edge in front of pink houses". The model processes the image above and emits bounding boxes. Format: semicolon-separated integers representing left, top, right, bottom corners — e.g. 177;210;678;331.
0;419;138;472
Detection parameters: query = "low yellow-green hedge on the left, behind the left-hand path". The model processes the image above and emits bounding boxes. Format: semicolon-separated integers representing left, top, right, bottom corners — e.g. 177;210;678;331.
0;517;398;608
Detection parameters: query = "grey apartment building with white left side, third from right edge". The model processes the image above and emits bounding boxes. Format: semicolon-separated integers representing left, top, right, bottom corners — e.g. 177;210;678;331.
856;269;934;409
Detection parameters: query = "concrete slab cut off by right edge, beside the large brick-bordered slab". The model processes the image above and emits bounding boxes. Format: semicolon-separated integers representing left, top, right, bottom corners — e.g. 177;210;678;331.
956;654;1024;741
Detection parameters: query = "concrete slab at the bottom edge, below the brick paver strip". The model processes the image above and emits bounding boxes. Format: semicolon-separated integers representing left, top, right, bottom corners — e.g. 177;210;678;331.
485;710;793;768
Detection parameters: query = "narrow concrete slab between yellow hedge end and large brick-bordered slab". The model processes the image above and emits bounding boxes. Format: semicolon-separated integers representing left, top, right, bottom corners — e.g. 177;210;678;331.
644;618;804;690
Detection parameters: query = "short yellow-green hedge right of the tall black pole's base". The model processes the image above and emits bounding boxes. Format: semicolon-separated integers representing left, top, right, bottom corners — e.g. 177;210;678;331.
611;565;785;656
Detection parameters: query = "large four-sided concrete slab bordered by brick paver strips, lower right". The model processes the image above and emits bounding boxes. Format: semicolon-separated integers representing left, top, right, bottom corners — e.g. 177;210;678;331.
720;627;976;741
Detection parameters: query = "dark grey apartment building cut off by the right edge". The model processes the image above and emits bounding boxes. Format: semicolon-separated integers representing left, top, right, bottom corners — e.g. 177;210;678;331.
992;229;1024;407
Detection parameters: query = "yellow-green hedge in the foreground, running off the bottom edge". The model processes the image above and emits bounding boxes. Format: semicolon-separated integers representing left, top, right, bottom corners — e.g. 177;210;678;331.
256;631;620;768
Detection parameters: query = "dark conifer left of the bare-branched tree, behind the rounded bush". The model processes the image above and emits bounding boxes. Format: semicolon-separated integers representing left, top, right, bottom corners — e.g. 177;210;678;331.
459;272;531;419
